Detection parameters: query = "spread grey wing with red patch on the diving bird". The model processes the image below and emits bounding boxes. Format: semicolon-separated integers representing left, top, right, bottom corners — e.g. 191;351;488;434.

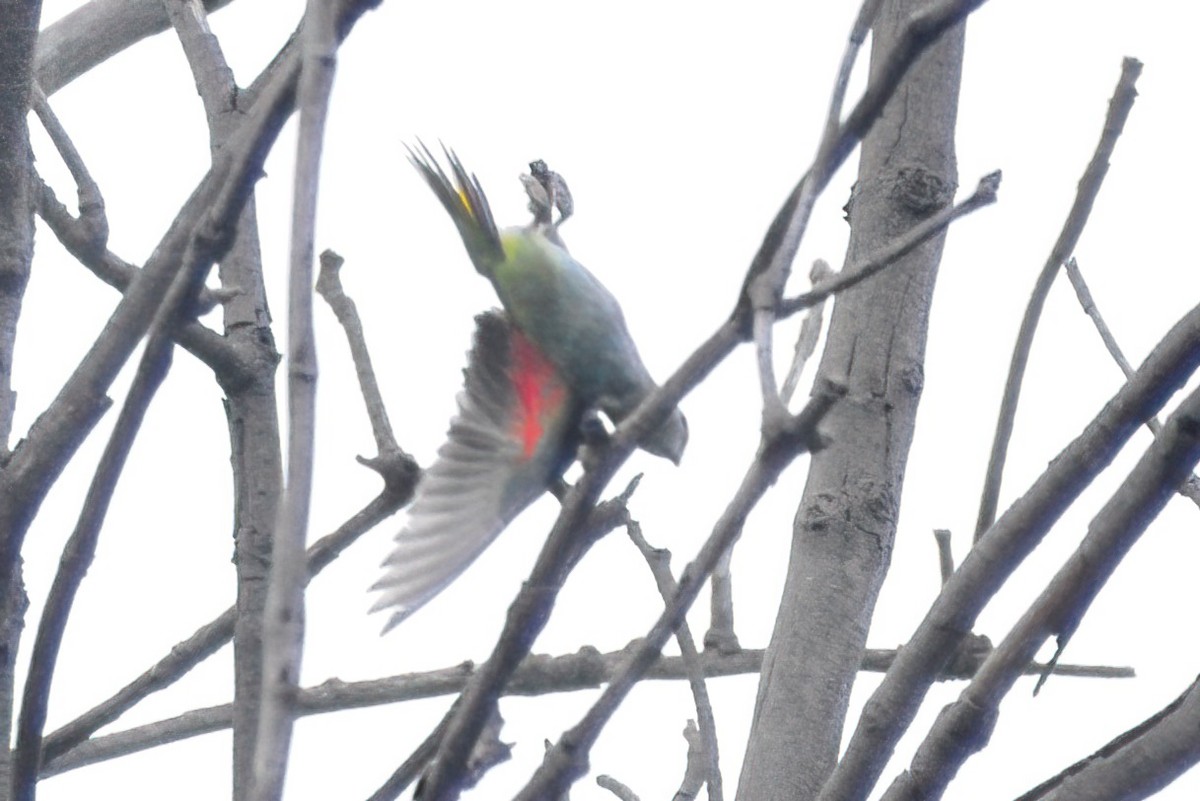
372;311;580;632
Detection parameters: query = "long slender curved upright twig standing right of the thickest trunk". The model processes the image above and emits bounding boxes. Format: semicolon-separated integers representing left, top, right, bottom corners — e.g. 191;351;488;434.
974;58;1141;541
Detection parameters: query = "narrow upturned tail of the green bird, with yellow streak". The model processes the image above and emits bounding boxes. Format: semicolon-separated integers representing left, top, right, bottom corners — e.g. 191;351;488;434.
404;140;504;279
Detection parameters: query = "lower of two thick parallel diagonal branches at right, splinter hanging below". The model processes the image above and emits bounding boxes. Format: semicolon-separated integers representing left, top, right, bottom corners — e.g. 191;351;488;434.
883;381;1200;801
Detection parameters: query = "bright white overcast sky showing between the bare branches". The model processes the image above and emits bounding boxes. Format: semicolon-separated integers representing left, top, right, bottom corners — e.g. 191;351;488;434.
14;0;1200;801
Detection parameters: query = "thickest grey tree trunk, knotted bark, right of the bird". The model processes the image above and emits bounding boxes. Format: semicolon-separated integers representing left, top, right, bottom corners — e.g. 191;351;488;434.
738;0;964;801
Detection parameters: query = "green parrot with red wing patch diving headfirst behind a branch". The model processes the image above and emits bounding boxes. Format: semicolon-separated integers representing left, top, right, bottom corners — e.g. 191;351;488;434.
372;145;688;632
